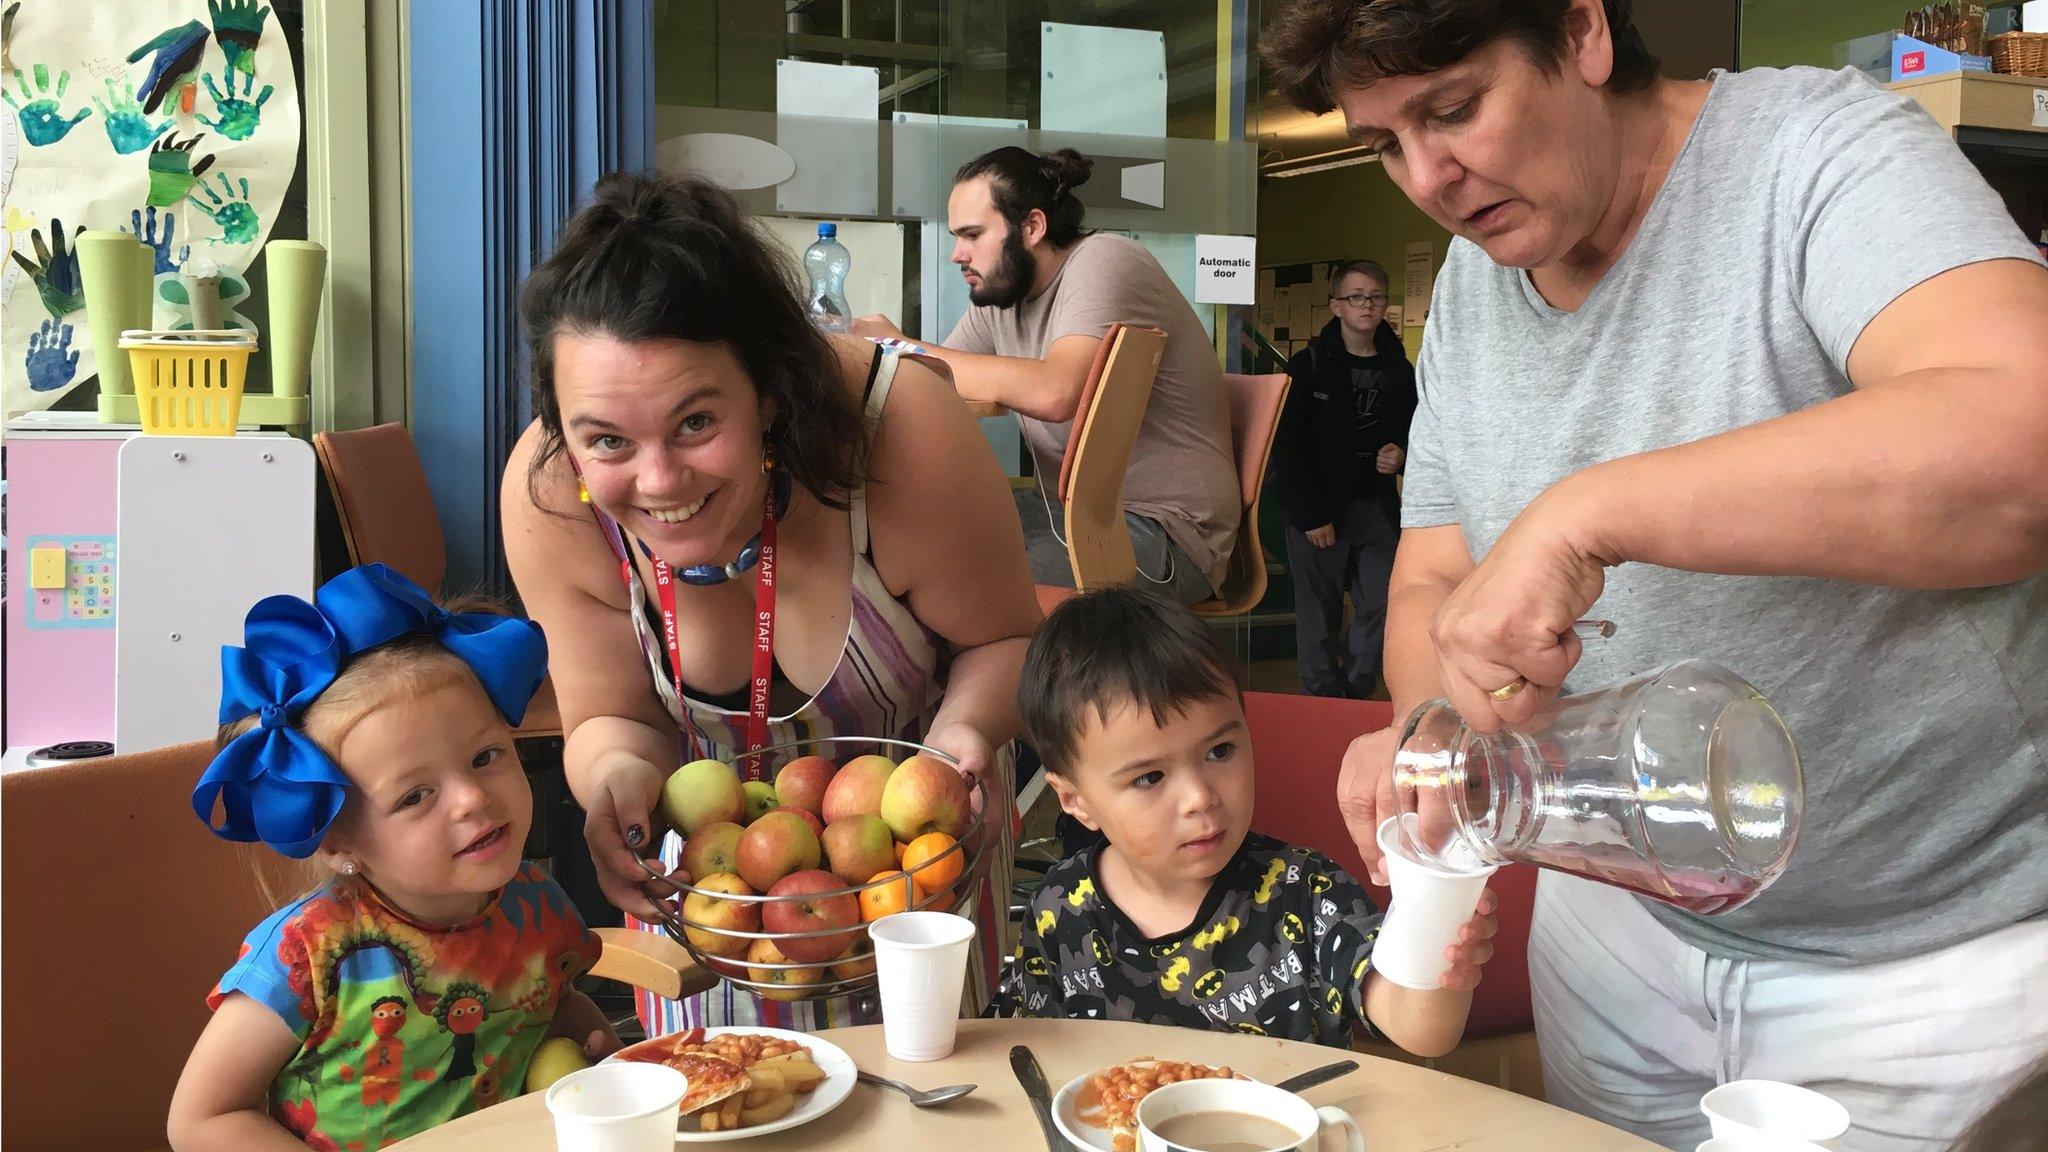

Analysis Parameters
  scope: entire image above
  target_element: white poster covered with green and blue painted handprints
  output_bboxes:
[0,0,301,416]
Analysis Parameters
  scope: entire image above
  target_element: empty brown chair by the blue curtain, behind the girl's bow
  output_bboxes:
[313,424,561,740]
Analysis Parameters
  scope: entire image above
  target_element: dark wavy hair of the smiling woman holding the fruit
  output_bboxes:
[518,172,868,508]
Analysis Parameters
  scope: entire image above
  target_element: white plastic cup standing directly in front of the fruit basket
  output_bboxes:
[868,912,975,1060]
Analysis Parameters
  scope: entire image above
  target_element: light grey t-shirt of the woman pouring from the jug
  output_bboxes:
[1401,68,2048,963]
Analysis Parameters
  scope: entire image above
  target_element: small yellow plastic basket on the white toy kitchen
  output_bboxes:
[121,328,256,437]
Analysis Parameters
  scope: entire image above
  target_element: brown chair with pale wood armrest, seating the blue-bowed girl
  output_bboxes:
[0,740,715,1152]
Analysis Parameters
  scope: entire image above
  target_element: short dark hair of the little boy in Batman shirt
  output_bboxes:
[1018,586,1237,779]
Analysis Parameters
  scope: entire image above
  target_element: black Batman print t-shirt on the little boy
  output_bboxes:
[1006,832,1380,1047]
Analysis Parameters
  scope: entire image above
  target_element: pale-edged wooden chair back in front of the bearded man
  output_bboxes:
[1038,324,1165,609]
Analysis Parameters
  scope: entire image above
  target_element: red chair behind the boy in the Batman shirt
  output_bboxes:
[1245,693,1542,1099]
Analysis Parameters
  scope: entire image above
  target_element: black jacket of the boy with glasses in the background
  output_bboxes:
[1274,318,1415,531]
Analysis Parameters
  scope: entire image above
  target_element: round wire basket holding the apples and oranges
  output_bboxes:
[643,736,997,1000]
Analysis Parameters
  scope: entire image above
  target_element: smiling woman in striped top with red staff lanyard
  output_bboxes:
[502,176,1038,1035]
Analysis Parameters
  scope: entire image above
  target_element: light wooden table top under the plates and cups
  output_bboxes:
[393,1021,1657,1152]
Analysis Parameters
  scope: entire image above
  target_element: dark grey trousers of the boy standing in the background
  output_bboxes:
[1286,498,1401,699]
